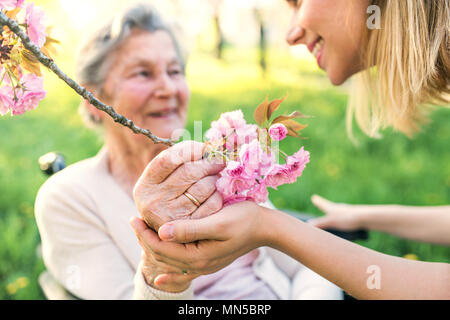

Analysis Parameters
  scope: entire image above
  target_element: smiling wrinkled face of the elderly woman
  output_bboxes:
[101,30,190,141]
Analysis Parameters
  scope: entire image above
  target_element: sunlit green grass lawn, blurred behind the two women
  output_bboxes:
[0,50,450,299]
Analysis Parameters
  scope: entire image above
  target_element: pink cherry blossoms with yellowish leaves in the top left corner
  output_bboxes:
[0,0,51,115]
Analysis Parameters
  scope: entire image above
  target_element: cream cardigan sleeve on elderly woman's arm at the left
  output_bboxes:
[35,177,192,300]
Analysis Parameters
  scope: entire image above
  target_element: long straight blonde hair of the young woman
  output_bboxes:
[347,0,450,137]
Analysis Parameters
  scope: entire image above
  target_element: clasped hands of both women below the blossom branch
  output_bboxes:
[131,141,268,292]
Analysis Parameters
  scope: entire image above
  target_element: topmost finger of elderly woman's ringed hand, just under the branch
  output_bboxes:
[138,141,204,185]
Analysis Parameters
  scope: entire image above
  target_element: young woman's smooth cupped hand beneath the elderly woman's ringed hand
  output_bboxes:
[130,201,270,282]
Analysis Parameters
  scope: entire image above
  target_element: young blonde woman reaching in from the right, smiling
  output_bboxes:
[131,0,450,299]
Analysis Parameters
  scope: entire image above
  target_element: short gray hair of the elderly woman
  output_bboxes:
[75,4,185,128]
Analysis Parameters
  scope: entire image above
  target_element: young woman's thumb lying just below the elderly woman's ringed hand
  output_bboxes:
[158,217,220,243]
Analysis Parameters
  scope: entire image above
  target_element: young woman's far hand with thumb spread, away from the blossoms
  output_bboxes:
[308,195,371,231]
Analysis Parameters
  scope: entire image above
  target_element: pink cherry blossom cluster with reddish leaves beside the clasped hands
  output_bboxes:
[206,99,309,205]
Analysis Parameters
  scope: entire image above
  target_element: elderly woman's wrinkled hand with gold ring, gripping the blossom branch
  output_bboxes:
[133,141,224,230]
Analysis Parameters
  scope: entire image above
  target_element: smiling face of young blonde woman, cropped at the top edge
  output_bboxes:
[286,0,369,85]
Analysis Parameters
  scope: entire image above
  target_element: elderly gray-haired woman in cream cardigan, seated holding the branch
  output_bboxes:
[35,5,342,299]
